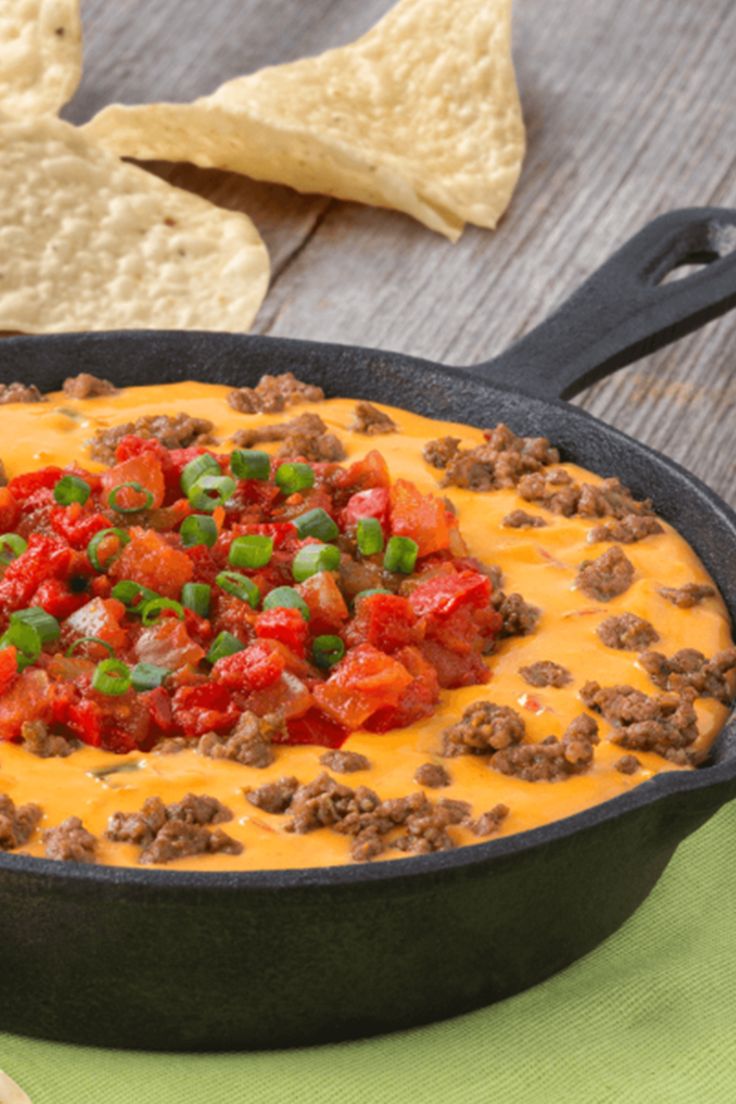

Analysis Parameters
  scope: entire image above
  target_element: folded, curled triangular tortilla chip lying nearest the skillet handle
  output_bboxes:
[83,0,524,241]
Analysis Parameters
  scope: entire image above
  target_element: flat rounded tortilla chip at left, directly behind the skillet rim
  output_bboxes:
[0,116,268,333]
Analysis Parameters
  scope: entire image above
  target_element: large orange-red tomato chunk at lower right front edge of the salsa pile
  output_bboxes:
[312,644,412,730]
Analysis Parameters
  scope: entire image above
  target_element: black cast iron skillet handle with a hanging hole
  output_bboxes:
[471,208,736,399]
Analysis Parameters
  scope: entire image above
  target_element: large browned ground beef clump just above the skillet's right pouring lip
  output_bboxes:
[580,682,697,764]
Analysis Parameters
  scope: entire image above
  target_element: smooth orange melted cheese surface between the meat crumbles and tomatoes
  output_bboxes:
[0,382,730,870]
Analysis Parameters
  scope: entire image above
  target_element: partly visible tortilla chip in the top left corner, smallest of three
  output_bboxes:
[0,0,82,118]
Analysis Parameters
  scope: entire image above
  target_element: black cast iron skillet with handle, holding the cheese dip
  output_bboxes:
[0,209,736,1050]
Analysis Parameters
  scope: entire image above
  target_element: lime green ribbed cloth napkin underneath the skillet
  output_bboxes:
[0,804,736,1104]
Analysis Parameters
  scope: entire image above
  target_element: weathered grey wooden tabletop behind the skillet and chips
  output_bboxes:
[64,0,736,505]
